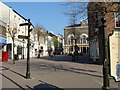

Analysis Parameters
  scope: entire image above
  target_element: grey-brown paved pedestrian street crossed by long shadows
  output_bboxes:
[0,56,118,90]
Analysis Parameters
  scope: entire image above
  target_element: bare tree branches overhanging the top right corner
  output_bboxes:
[63,0,120,20]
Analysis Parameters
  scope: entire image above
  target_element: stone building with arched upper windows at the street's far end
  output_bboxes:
[63,20,89,55]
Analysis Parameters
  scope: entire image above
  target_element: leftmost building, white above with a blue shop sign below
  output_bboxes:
[0,2,9,60]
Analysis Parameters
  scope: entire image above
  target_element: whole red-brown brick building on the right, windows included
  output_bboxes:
[88,2,120,64]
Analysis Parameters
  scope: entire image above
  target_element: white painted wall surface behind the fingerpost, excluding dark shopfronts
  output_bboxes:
[0,2,34,58]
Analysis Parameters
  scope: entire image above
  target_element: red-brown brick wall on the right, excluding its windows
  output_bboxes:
[88,3,120,64]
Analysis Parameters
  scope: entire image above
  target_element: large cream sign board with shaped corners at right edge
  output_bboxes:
[109,30,120,81]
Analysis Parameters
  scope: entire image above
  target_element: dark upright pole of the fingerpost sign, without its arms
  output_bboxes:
[26,19,30,79]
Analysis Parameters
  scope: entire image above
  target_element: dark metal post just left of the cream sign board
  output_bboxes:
[101,18,110,90]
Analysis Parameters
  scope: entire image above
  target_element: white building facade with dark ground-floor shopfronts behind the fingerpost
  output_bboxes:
[0,2,34,59]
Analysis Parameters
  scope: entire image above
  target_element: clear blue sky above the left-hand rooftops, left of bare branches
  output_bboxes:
[5,2,84,35]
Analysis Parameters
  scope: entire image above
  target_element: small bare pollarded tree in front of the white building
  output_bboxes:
[7,26,20,64]
